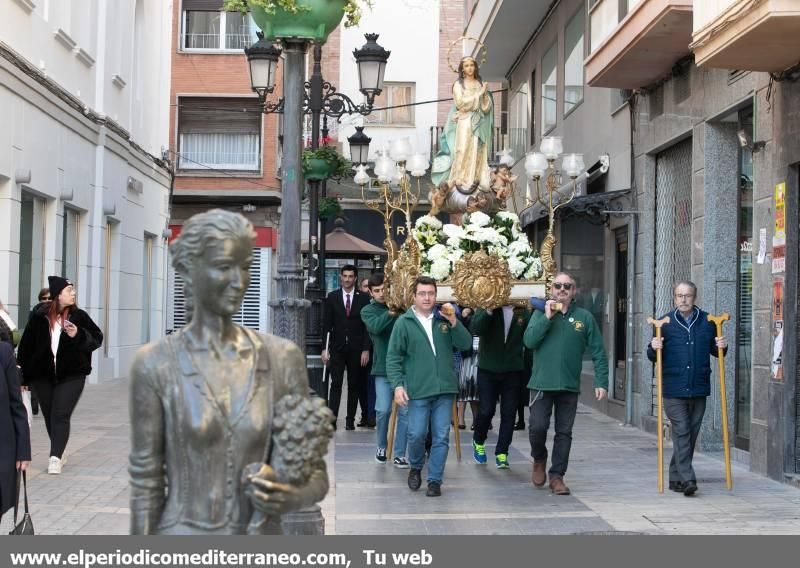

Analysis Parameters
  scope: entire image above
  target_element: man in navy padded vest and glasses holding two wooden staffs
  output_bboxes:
[647,281,728,497]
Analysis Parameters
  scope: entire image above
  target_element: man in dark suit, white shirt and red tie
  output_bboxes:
[322,264,370,430]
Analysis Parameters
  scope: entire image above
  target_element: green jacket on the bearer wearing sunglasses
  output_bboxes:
[523,304,608,392]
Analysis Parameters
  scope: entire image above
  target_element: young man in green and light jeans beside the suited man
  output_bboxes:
[361,272,408,469]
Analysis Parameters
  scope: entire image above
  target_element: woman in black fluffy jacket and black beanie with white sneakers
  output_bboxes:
[17,276,103,474]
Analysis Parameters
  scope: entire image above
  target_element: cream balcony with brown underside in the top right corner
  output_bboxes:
[691,0,800,72]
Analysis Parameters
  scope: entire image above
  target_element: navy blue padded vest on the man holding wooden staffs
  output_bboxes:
[647,306,718,398]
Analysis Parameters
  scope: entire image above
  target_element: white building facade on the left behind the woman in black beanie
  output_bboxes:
[0,0,172,382]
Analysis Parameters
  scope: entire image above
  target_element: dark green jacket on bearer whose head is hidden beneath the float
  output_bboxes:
[469,308,531,373]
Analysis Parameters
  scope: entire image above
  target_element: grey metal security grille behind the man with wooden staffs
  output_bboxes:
[652,138,692,414]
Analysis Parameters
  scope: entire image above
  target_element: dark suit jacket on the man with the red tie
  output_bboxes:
[322,288,372,351]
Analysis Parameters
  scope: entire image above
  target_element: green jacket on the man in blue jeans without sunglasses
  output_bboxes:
[386,309,472,399]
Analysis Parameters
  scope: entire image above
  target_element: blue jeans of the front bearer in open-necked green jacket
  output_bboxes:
[408,394,456,483]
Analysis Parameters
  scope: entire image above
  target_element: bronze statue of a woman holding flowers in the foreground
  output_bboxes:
[129,209,332,534]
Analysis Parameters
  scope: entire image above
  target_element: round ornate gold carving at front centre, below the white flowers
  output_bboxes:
[453,251,511,310]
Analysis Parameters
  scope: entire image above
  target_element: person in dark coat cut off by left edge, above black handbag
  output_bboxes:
[0,343,31,518]
